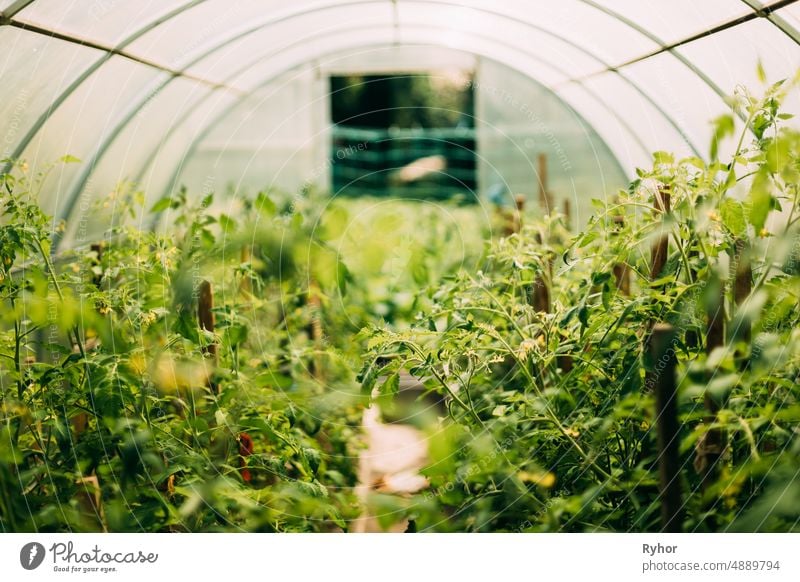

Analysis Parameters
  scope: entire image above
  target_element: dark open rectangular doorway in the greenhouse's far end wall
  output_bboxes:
[330,71,477,202]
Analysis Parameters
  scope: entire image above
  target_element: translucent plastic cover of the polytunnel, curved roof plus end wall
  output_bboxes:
[2,0,800,244]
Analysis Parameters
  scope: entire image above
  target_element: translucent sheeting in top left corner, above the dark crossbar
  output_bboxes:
[14,0,192,46]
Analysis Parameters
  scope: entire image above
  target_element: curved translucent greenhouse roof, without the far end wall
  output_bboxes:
[0,0,800,237]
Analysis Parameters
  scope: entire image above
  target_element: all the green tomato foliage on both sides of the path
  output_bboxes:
[0,84,800,531]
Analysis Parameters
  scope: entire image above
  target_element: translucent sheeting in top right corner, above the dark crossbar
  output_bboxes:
[596,0,752,44]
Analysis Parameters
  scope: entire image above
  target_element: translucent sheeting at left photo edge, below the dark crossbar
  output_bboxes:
[0,26,102,158]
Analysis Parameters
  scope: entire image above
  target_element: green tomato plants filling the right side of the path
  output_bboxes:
[362,84,800,531]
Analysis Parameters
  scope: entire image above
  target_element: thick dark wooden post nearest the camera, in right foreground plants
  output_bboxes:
[648,323,683,532]
